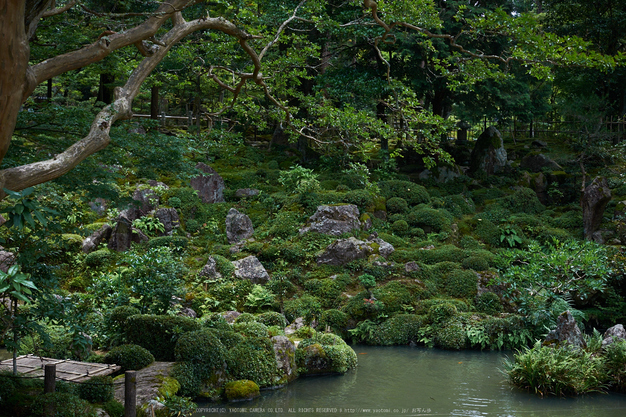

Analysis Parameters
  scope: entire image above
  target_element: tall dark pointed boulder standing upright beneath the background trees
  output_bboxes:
[469,126,508,175]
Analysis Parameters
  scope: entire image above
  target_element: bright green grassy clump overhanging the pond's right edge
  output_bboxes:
[505,342,606,396]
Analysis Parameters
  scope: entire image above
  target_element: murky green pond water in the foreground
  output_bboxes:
[194,346,626,417]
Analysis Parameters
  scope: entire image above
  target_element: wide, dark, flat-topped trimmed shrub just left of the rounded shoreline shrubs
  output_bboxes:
[126,314,200,362]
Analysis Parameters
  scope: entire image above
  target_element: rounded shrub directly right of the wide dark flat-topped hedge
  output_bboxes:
[174,329,228,368]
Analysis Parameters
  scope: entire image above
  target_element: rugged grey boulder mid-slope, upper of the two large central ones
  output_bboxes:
[300,204,361,236]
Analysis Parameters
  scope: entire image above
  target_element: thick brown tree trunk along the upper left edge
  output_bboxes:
[0,0,30,166]
